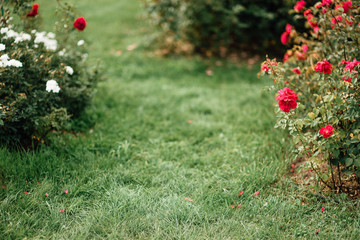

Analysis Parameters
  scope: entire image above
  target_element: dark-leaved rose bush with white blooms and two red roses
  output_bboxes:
[0,0,99,148]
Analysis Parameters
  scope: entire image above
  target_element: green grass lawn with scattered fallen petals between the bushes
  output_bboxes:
[0,0,360,239]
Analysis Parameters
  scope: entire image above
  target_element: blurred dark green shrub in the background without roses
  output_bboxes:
[146,0,294,54]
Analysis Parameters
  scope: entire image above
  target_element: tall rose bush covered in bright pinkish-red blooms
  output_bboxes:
[261,0,360,194]
